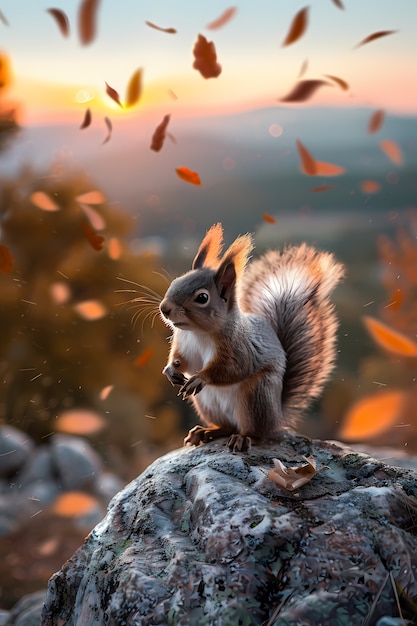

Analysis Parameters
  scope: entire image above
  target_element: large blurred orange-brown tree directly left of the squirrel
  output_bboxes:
[0,164,179,470]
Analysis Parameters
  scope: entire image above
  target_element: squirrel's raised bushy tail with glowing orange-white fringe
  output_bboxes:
[240,244,343,422]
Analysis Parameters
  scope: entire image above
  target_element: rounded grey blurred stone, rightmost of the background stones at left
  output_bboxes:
[51,435,103,491]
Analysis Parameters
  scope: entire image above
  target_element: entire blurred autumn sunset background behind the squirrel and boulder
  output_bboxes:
[0,0,417,608]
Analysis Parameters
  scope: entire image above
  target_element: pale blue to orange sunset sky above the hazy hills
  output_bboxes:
[0,0,417,124]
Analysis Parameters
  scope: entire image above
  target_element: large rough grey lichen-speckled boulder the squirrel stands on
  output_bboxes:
[41,433,417,626]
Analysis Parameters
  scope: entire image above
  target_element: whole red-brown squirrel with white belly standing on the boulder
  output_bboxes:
[159,223,344,452]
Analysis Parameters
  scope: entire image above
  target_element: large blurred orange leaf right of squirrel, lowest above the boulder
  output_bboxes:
[338,390,406,441]
